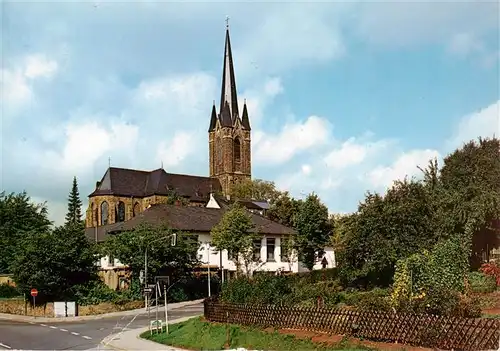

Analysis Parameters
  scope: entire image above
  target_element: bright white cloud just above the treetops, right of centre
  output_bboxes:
[367,149,440,189]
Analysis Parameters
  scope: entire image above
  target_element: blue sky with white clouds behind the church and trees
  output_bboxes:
[0,0,500,224]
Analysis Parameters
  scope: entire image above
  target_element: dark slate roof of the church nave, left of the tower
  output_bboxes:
[89,167,222,202]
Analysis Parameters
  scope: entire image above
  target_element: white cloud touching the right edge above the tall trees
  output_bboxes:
[447,100,500,149]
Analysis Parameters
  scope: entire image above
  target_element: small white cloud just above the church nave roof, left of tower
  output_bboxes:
[156,131,196,167]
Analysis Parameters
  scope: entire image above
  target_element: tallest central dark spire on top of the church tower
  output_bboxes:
[220,18,239,120]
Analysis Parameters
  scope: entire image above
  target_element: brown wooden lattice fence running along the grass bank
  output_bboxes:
[204,297,500,351]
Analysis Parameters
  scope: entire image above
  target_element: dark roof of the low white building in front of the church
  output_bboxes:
[85,204,294,241]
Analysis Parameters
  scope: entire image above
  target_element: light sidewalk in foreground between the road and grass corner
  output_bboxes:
[101,316,196,351]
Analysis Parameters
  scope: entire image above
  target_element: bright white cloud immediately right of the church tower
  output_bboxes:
[253,116,331,165]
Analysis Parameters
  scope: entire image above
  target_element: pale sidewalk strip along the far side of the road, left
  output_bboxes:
[0,299,205,324]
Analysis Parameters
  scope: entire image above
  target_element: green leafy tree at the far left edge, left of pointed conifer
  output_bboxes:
[0,192,51,273]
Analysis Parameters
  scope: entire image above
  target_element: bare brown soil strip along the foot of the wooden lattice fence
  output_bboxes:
[279,329,433,351]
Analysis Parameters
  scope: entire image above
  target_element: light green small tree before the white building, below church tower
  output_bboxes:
[211,204,260,274]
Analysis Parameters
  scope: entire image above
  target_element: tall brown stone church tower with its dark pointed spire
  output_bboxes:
[208,21,252,195]
